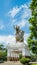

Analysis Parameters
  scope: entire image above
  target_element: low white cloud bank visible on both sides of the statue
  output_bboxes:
[0,33,29,45]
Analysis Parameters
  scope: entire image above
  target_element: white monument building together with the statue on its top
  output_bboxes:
[7,26,30,61]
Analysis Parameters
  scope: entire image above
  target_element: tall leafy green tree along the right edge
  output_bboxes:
[28,0,37,55]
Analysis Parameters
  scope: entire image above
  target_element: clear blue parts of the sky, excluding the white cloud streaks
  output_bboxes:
[0,0,31,35]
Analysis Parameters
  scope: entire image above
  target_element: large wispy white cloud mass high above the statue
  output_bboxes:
[8,4,31,28]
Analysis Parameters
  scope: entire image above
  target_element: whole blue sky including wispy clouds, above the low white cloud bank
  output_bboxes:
[0,0,31,44]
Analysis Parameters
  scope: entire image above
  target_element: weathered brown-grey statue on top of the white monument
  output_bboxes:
[14,26,24,42]
